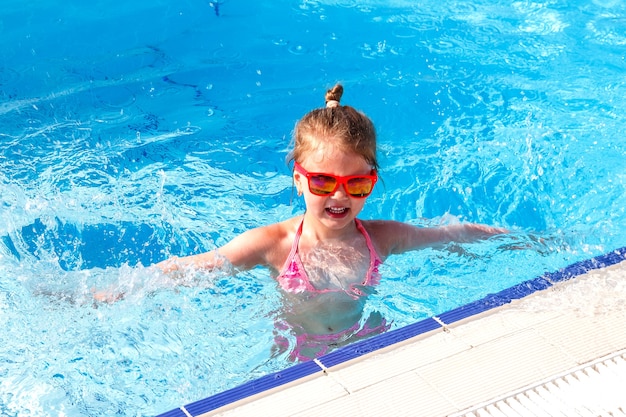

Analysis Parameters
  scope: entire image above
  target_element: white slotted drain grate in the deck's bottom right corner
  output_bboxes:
[450,350,626,417]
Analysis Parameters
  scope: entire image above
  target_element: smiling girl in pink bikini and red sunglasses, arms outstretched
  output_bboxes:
[152,85,506,360]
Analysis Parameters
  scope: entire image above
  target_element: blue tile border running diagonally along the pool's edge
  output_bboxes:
[157,247,626,417]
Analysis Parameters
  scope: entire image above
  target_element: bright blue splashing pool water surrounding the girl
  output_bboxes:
[0,0,626,416]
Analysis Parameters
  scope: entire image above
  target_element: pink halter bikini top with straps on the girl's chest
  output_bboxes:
[277,218,382,295]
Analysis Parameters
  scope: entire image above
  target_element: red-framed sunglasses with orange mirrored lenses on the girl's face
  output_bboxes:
[293,162,378,198]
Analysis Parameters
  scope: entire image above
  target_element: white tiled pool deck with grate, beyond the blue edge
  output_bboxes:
[160,249,626,417]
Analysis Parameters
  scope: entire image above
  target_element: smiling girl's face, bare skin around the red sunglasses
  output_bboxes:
[293,145,372,234]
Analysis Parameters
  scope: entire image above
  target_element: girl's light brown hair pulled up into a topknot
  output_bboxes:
[287,84,378,170]
